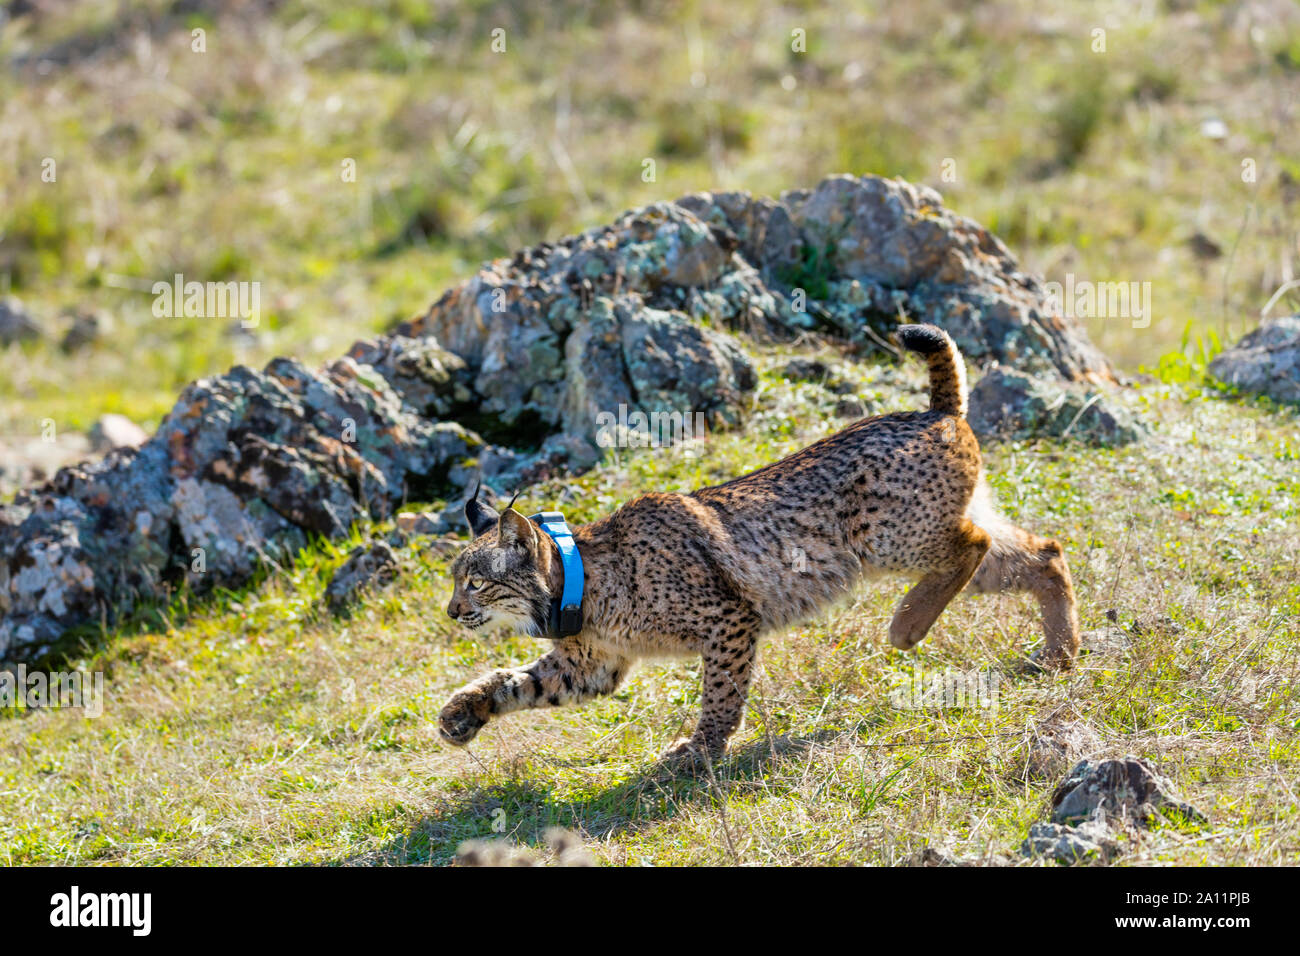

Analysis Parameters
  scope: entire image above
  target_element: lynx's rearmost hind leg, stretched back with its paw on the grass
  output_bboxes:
[970,519,1079,667]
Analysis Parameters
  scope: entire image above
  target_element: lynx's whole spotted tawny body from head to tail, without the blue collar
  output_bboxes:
[439,325,1079,758]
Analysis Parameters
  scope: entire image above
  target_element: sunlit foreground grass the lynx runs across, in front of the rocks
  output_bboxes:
[0,349,1300,865]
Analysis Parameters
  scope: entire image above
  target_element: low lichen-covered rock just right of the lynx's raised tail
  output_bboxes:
[966,365,1145,445]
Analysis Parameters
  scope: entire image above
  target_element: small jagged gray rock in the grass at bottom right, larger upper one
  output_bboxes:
[1052,757,1205,826]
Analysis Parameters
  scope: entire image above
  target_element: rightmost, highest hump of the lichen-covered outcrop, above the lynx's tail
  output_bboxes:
[676,176,1114,381]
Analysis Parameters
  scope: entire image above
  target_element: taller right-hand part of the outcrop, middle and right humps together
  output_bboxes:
[402,176,1113,421]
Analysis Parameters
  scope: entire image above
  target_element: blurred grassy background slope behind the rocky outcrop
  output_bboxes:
[0,0,1300,433]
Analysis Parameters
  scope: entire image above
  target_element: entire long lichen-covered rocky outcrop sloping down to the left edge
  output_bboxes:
[0,176,1112,659]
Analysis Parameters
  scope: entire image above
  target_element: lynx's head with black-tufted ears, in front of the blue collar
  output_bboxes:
[447,488,551,635]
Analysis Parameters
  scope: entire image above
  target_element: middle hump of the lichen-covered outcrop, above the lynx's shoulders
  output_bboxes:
[399,203,759,440]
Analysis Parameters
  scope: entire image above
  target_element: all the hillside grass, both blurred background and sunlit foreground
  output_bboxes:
[0,0,1300,864]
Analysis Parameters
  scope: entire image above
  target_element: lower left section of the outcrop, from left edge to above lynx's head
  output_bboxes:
[0,358,484,659]
